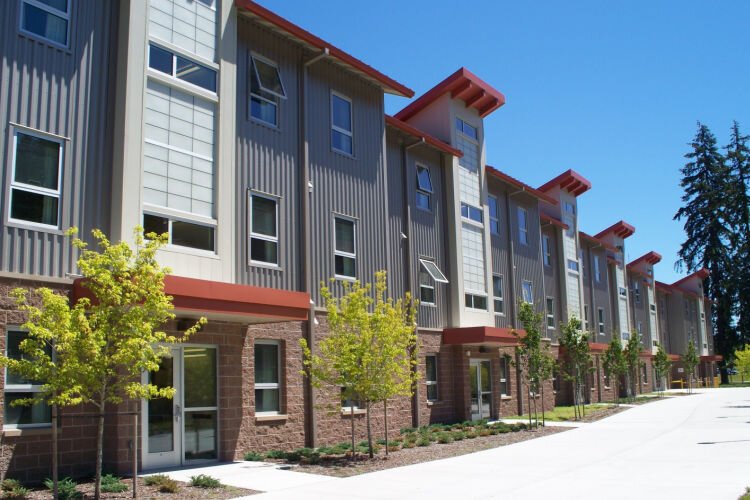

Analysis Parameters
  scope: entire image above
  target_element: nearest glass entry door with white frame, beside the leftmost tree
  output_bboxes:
[142,346,218,469]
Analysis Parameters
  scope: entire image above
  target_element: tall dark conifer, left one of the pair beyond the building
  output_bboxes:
[674,122,738,378]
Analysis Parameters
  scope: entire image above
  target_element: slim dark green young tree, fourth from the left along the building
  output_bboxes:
[559,316,591,420]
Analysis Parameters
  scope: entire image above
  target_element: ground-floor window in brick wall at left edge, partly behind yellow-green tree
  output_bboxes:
[3,328,52,428]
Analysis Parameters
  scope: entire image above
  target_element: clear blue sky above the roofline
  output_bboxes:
[260,0,750,282]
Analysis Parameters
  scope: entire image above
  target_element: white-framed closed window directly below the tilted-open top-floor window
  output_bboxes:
[250,194,279,265]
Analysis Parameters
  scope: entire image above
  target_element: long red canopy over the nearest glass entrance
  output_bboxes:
[73,275,310,322]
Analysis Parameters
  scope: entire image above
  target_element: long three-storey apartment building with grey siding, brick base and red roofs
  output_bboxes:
[0,0,715,480]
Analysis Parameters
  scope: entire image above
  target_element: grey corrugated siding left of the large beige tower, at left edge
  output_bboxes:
[0,0,119,277]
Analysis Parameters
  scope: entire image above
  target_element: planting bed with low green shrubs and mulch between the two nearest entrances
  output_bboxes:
[248,421,566,477]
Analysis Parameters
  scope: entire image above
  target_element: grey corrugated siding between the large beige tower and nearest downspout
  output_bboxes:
[236,17,302,290]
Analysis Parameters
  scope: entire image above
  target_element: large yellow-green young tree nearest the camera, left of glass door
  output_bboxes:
[0,228,206,498]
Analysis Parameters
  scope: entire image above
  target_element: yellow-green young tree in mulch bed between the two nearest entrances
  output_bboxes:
[300,271,418,457]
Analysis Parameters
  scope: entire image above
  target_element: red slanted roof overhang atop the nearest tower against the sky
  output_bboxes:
[396,68,505,121]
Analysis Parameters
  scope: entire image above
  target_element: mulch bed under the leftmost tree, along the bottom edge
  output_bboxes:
[19,478,261,500]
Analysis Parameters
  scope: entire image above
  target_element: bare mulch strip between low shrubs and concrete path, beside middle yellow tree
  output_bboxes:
[292,427,569,477]
